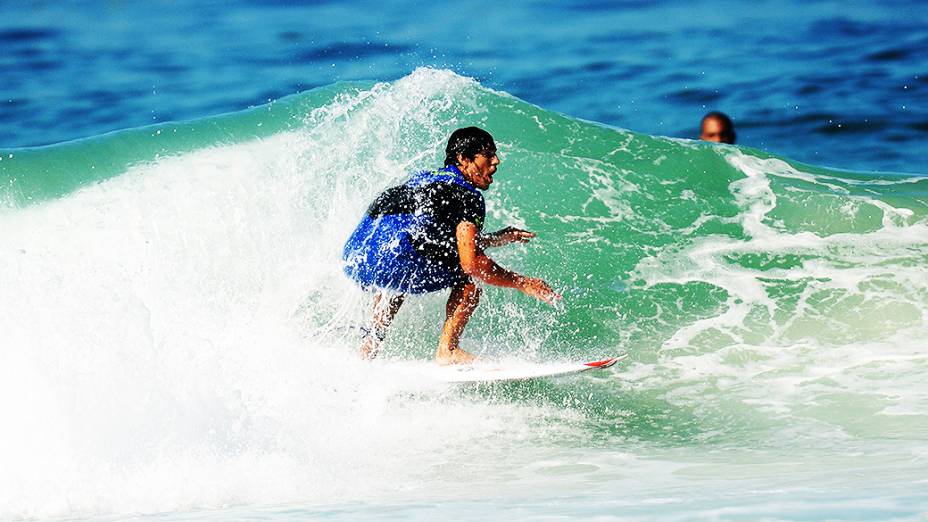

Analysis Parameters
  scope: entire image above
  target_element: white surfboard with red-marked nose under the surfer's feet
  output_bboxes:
[434,354,628,383]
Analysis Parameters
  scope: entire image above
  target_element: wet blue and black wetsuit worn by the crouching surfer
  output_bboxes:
[343,165,486,293]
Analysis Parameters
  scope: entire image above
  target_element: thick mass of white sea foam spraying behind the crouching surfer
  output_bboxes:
[0,71,588,518]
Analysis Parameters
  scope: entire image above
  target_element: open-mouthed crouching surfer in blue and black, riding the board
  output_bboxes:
[343,127,561,364]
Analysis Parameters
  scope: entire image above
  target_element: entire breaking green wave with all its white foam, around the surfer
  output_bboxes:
[0,69,928,520]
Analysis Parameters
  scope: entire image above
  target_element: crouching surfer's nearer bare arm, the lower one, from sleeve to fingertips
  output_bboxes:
[456,221,561,304]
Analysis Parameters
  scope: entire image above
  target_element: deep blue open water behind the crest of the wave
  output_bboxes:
[0,0,928,173]
